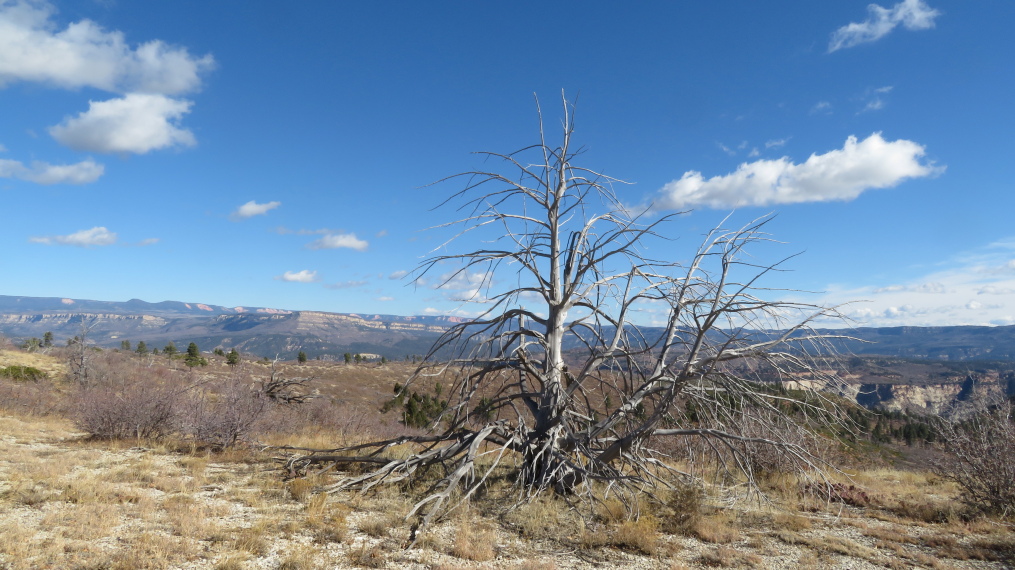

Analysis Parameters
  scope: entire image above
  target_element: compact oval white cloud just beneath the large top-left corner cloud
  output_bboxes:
[49,93,197,154]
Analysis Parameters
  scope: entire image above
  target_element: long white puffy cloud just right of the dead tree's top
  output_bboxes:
[654,133,944,210]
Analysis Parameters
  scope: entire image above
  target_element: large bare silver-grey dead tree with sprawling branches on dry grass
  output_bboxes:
[287,95,856,539]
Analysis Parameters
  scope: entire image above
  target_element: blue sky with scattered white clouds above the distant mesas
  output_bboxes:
[0,0,1015,326]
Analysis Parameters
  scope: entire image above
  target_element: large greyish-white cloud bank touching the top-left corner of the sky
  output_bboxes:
[0,0,215,94]
